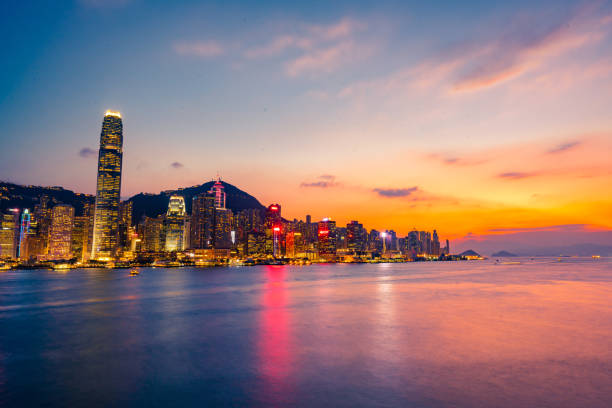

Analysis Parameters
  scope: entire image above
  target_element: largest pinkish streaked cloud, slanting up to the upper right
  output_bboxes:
[337,4,612,99]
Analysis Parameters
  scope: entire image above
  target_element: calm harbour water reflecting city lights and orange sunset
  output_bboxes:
[0,259,612,407]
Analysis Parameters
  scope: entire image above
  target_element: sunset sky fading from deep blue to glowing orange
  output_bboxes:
[0,0,612,253]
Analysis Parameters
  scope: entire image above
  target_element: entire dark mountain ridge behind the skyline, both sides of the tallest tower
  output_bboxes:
[0,181,265,223]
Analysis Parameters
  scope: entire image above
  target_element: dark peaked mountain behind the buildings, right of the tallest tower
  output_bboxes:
[129,181,266,222]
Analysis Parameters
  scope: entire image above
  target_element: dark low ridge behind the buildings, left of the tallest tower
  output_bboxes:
[0,182,96,215]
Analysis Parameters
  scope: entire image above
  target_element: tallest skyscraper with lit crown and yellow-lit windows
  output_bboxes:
[91,111,123,260]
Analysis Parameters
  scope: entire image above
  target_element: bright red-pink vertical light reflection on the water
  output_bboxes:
[258,266,292,402]
